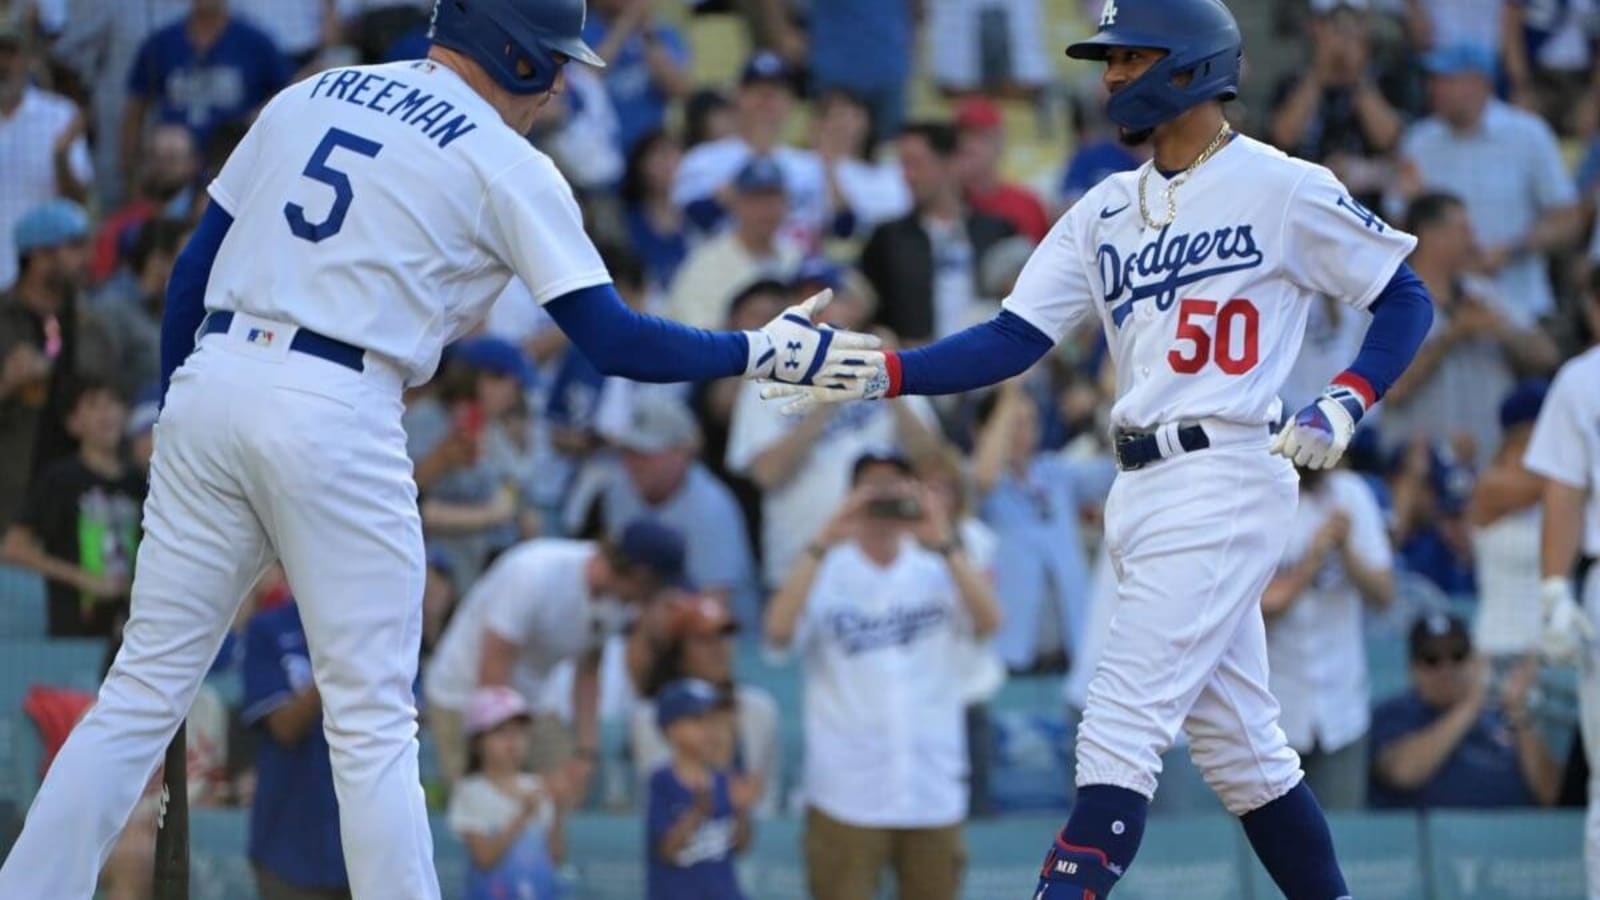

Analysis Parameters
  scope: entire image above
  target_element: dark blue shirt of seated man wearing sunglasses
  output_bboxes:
[1368,692,1538,809]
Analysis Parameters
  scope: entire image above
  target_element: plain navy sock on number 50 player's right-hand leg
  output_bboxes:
[1240,781,1350,900]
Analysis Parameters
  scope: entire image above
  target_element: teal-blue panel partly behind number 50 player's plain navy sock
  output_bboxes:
[1246,812,1427,900]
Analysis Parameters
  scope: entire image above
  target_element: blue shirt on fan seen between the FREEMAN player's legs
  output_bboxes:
[243,604,349,889]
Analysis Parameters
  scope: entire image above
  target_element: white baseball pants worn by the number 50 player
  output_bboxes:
[1077,420,1301,815]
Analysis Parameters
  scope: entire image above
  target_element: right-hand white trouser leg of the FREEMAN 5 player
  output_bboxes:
[236,369,438,900]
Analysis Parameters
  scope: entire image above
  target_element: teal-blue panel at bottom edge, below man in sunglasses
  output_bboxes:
[1426,810,1584,900]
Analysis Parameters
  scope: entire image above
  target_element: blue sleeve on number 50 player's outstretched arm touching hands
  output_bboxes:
[888,311,1054,396]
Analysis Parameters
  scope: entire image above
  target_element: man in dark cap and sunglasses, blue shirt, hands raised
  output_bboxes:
[1368,613,1562,809]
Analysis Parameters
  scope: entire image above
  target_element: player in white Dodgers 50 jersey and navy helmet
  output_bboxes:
[763,0,1432,900]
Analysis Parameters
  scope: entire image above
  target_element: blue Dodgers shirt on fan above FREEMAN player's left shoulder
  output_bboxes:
[128,19,291,151]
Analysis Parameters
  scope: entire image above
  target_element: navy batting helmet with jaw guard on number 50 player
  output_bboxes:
[1067,0,1245,131]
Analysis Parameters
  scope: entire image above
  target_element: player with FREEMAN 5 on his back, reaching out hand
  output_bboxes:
[0,0,870,900]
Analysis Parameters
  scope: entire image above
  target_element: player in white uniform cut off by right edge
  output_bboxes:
[1523,267,1600,900]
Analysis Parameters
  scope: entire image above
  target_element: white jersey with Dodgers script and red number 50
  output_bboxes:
[1005,135,1416,429]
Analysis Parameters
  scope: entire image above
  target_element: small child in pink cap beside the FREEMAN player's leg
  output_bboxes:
[450,685,565,900]
